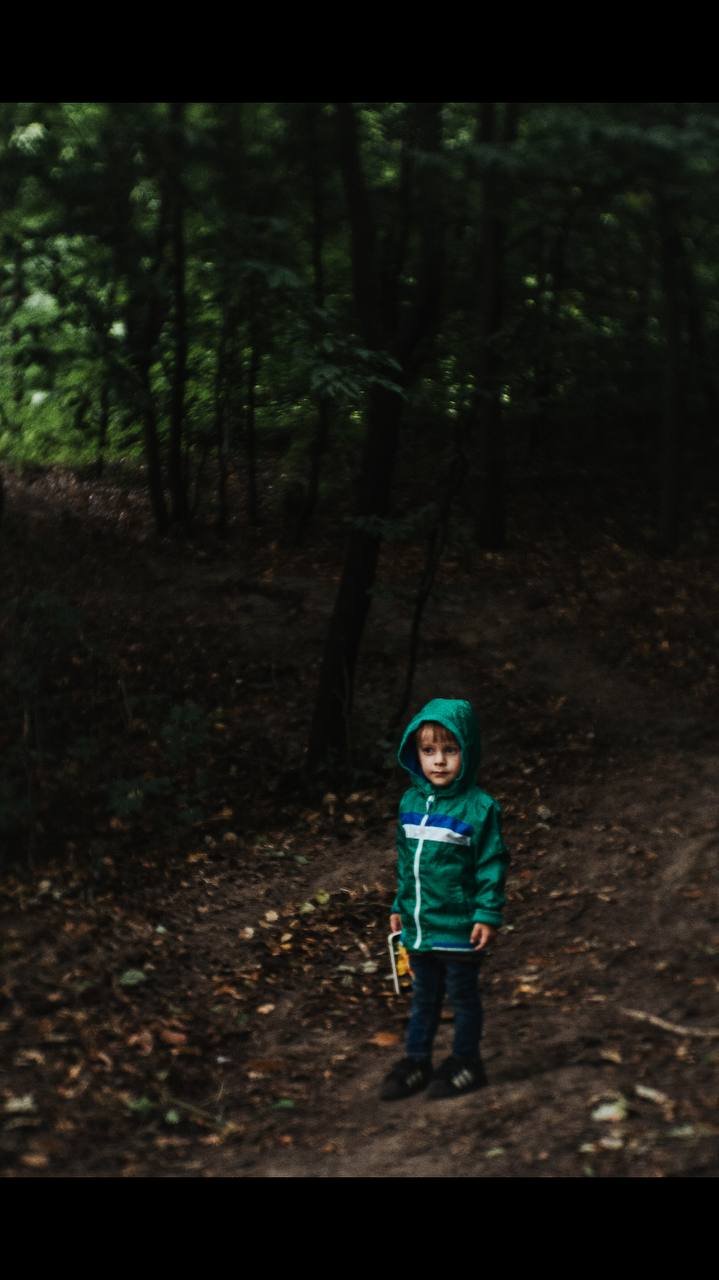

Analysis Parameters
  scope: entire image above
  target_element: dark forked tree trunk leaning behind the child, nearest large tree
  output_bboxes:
[307,102,444,771]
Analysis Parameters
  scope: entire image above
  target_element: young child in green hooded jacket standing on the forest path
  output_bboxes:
[381,698,507,1101]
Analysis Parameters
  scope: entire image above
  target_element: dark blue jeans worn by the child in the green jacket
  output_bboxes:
[407,951,482,1057]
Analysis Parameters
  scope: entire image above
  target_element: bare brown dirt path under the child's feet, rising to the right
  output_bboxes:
[177,737,719,1178]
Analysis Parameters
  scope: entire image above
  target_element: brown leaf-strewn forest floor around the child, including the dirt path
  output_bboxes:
[0,472,719,1178]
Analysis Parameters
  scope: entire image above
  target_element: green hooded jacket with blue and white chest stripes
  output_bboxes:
[391,698,508,952]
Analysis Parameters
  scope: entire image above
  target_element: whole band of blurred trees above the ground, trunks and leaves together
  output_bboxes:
[0,102,719,765]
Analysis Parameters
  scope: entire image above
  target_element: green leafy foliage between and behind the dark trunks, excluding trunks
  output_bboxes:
[0,102,719,535]
